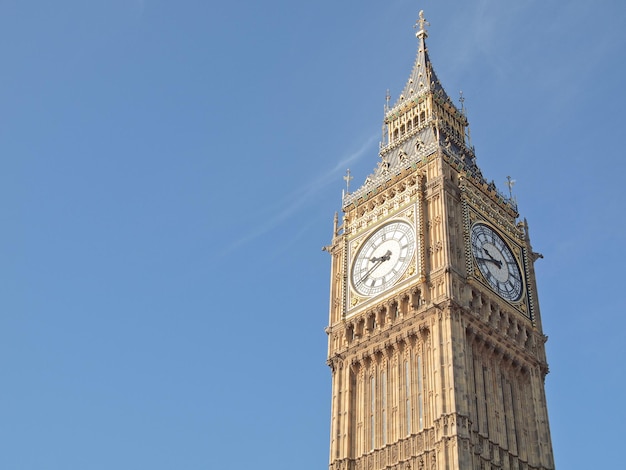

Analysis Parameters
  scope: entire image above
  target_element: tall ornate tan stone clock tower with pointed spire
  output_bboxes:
[326,12,554,470]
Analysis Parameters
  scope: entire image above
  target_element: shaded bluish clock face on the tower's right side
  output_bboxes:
[471,224,522,302]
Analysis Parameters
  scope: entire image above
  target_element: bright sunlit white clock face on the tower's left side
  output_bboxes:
[351,221,415,296]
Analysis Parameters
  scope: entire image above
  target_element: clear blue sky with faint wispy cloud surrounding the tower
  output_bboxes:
[0,0,626,470]
